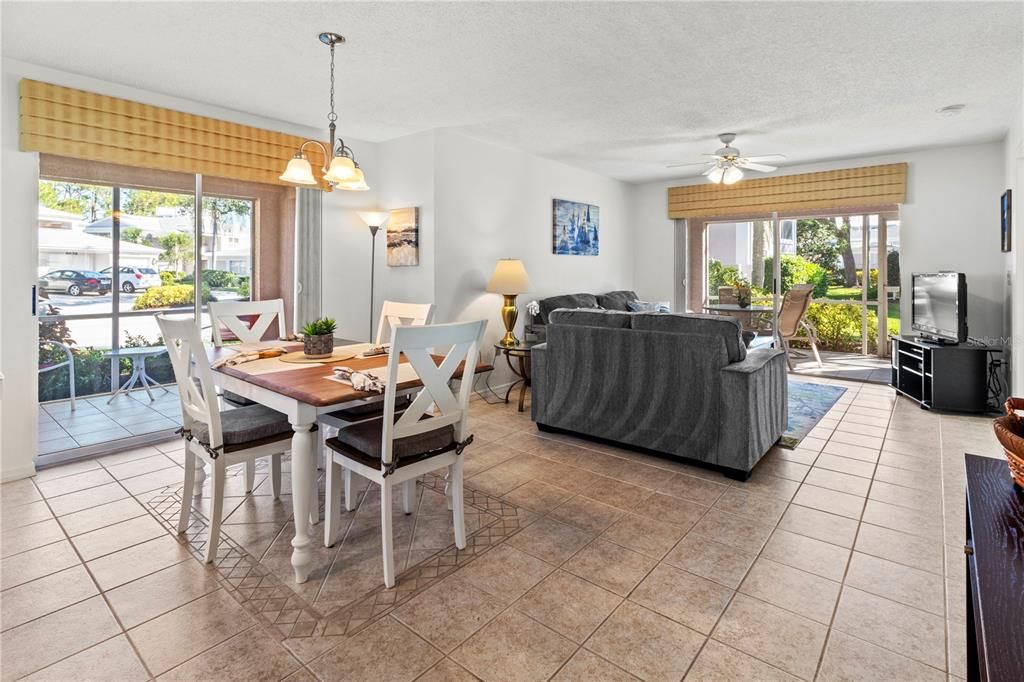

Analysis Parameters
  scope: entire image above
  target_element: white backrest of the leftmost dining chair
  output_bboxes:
[155,314,223,447]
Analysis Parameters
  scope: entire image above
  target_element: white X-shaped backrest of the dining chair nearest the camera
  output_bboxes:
[381,319,486,464]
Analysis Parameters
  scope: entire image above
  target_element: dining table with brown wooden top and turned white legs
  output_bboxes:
[208,340,494,583]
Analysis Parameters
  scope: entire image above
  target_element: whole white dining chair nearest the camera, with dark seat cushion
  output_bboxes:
[324,319,486,588]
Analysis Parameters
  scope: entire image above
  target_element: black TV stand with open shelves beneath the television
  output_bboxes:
[889,336,997,413]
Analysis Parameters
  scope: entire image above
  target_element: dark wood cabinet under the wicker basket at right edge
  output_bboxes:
[964,455,1024,682]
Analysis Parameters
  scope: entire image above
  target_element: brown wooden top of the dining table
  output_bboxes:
[208,341,494,408]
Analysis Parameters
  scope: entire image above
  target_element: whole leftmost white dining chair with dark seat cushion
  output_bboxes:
[156,314,293,563]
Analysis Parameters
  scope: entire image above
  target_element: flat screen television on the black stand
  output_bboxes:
[911,272,967,343]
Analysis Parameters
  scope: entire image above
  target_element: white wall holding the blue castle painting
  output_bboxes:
[434,131,635,376]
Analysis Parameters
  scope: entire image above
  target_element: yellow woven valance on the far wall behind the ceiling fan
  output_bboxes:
[669,163,906,219]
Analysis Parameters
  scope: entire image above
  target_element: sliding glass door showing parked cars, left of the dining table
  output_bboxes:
[37,179,255,464]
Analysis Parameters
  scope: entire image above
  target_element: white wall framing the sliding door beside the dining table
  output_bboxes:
[0,58,376,480]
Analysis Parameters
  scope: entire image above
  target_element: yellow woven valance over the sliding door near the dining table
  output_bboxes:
[18,79,330,190]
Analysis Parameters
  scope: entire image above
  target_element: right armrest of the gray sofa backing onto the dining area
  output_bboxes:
[719,348,788,471]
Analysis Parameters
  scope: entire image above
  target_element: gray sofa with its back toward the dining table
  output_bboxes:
[532,309,787,480]
